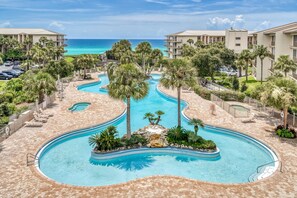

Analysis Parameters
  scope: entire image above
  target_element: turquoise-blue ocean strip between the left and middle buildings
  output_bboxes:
[65,39,167,56]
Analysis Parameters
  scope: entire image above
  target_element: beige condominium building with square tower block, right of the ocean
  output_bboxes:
[165,29,249,58]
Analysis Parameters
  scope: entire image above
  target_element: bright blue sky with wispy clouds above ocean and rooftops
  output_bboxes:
[0,0,297,38]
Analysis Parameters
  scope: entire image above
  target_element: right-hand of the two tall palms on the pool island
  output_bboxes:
[160,59,197,126]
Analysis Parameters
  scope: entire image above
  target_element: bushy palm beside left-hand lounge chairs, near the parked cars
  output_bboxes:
[24,71,56,104]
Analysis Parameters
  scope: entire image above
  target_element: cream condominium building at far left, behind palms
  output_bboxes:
[0,28,65,46]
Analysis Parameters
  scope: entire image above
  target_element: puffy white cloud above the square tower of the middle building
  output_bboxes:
[207,15,245,29]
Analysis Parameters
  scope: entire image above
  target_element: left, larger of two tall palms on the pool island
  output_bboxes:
[107,64,149,138]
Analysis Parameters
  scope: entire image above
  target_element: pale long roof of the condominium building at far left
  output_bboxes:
[0,28,63,35]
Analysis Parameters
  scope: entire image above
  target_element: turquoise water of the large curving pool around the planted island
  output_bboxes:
[39,75,274,186]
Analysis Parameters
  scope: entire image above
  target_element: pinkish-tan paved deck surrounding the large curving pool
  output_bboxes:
[0,73,297,197]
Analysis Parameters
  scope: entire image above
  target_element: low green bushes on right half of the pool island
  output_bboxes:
[167,127,216,150]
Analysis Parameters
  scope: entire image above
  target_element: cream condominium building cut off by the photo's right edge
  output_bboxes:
[253,22,297,80]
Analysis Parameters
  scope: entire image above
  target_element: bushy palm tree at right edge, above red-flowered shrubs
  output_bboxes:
[260,77,297,128]
